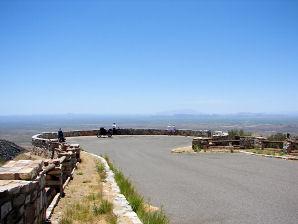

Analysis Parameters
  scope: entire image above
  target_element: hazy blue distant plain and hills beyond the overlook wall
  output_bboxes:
[0,114,298,146]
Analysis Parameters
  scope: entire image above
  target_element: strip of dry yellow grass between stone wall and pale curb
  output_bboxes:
[51,153,117,224]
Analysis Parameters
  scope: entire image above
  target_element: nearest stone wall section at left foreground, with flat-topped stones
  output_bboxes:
[0,139,80,224]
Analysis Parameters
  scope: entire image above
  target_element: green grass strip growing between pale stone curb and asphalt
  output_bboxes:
[104,156,169,224]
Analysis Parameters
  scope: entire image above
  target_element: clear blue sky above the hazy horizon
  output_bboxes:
[0,0,298,115]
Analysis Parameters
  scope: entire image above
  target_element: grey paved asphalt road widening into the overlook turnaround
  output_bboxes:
[69,136,298,224]
